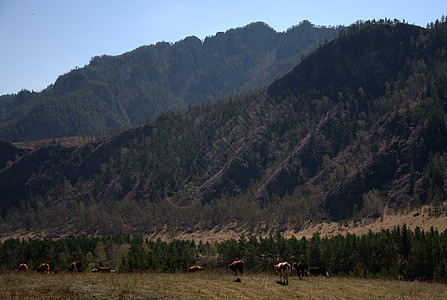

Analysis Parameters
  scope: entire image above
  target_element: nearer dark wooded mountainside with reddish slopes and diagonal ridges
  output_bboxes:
[0,20,447,236]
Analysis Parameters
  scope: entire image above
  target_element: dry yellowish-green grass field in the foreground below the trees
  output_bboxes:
[0,271,447,300]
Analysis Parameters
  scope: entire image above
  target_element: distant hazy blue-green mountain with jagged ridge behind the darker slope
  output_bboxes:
[0,21,340,142]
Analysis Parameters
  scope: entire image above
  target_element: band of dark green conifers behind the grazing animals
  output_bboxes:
[0,225,447,282]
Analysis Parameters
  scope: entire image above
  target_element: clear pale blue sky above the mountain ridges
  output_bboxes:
[0,0,447,95]
